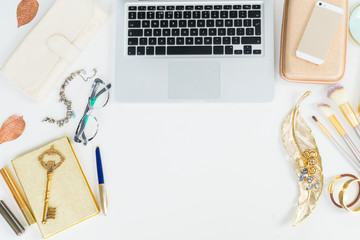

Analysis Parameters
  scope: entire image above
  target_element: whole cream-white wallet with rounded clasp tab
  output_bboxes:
[1,0,107,101]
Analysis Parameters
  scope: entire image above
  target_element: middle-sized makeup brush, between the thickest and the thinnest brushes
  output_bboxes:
[318,103,360,163]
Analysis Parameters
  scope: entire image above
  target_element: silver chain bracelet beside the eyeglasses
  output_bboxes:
[42,68,97,127]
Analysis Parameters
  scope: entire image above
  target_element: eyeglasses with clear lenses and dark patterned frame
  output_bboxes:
[74,78,111,145]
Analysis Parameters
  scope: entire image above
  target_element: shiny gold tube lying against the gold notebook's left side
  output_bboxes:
[0,168,36,225]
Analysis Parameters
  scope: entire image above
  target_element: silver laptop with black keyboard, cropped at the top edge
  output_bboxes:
[115,0,274,102]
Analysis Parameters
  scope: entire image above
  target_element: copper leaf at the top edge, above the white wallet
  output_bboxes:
[16,0,39,28]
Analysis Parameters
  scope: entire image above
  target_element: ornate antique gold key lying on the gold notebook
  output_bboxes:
[38,145,65,224]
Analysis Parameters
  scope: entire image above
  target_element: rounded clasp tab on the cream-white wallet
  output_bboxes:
[48,34,80,64]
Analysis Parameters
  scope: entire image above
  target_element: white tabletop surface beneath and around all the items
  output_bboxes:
[0,0,360,240]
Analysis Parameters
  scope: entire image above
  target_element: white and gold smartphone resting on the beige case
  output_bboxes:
[296,1,344,65]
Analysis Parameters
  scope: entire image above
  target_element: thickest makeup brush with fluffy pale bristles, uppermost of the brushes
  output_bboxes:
[328,85,360,138]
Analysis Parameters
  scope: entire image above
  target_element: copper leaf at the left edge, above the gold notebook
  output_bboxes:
[0,115,25,144]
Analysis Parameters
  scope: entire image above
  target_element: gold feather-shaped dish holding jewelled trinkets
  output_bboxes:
[281,91,324,226]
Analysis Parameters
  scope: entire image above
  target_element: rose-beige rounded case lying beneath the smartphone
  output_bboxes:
[280,0,348,83]
